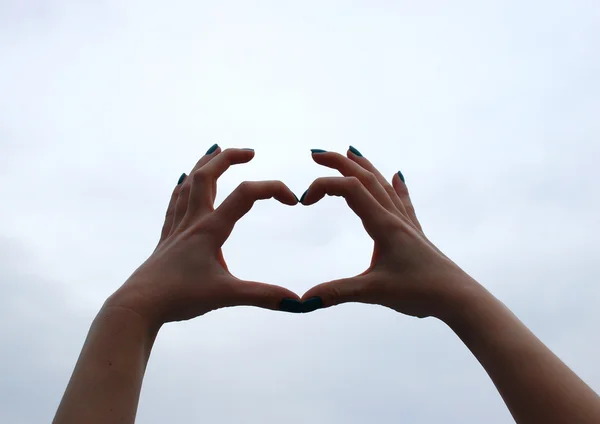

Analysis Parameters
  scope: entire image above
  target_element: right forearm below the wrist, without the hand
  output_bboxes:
[443,283,600,424]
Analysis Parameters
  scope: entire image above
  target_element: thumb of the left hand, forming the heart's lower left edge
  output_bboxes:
[233,280,302,312]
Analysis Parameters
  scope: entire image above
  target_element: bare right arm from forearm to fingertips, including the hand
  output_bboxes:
[302,148,600,424]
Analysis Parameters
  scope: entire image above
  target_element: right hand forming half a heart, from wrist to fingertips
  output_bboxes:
[301,148,477,317]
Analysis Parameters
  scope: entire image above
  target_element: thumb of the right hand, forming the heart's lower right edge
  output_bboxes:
[302,274,373,312]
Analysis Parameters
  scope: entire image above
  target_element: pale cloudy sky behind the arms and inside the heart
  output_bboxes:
[0,0,600,424]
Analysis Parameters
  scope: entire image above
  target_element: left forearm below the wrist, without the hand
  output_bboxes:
[53,306,158,424]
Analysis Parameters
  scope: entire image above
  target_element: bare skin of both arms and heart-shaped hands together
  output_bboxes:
[54,149,600,424]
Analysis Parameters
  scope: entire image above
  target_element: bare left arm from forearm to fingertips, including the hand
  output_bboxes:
[54,148,300,424]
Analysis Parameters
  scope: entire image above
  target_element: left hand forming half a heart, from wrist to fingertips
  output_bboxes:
[105,147,299,325]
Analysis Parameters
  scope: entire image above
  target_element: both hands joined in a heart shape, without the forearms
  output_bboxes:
[106,146,470,326]
